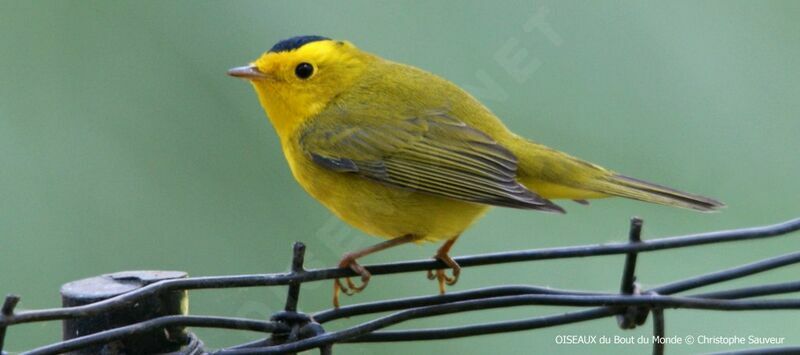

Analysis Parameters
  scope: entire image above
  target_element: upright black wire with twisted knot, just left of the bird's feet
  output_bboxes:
[266,242,333,355]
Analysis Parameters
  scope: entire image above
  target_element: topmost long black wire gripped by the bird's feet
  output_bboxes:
[0,218,800,327]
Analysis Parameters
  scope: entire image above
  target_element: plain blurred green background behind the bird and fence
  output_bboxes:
[0,1,800,354]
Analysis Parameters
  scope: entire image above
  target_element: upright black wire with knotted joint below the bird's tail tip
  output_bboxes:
[617,217,664,355]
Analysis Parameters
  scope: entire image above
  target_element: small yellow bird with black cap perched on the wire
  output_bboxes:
[228,36,724,307]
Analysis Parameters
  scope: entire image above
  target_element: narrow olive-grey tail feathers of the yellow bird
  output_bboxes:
[597,174,725,212]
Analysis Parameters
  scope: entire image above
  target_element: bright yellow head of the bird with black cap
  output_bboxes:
[228,36,370,137]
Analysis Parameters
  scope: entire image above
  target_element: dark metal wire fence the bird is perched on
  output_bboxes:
[0,218,800,355]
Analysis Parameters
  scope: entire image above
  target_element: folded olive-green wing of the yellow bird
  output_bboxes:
[299,111,564,213]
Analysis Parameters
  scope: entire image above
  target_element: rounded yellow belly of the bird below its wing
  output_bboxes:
[284,141,488,241]
